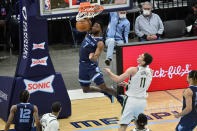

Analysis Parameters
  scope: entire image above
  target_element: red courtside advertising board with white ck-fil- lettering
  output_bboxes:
[117,37,197,91]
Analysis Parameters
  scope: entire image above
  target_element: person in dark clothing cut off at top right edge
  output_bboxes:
[185,2,197,36]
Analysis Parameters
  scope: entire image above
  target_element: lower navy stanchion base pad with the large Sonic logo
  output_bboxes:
[11,73,71,118]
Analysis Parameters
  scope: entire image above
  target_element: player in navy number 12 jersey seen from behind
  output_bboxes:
[5,90,41,131]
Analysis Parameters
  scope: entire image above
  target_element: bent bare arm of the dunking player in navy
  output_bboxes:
[89,41,104,61]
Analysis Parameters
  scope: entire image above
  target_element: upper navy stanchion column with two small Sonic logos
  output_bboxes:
[16,0,55,78]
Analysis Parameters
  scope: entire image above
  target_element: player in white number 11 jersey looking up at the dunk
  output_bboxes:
[105,53,153,131]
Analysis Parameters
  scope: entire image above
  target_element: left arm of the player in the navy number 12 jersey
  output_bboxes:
[4,105,17,131]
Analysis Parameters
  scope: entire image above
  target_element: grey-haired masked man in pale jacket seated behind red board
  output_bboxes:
[135,2,164,41]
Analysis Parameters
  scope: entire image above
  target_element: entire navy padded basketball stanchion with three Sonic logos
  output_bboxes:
[0,0,71,121]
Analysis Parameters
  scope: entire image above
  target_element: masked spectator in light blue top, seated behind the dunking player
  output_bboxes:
[105,11,130,66]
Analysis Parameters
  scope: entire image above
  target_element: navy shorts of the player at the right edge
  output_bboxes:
[176,115,197,131]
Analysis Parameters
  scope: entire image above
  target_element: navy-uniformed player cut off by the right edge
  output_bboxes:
[174,70,197,131]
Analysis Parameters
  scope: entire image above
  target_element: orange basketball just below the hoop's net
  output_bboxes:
[76,19,91,32]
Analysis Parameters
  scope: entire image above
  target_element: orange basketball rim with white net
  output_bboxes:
[76,2,104,21]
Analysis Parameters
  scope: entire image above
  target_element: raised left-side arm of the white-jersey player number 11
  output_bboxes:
[104,67,136,83]
